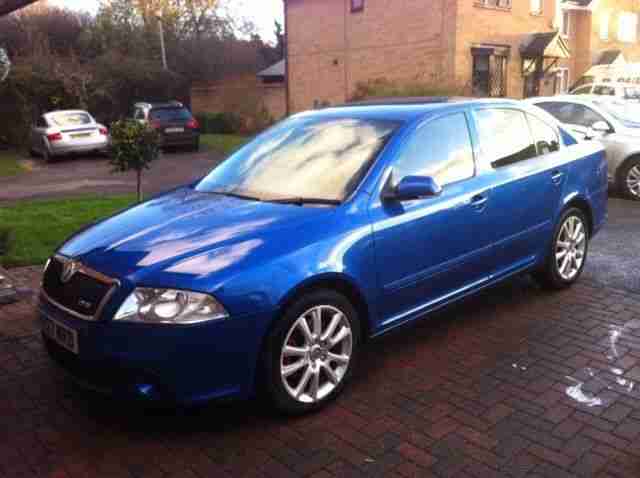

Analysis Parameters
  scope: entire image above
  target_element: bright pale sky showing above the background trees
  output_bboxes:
[49,0,284,41]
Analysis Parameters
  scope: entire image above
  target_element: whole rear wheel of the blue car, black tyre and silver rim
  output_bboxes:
[534,207,589,289]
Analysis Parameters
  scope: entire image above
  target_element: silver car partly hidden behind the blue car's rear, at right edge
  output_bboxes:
[529,96,640,201]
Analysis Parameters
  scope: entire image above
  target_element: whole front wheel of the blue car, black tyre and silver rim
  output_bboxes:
[263,290,361,415]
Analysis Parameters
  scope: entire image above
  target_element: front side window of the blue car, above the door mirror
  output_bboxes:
[393,113,475,186]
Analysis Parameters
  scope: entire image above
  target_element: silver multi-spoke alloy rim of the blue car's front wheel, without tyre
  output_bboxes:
[280,305,353,404]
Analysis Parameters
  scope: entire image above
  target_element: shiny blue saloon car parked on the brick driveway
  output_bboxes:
[39,100,607,413]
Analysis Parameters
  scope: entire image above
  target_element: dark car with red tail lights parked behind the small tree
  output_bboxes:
[133,101,200,151]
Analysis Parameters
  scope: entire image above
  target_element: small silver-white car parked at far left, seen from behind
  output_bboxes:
[29,110,109,162]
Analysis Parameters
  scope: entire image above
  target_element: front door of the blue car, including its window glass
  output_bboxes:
[370,111,493,330]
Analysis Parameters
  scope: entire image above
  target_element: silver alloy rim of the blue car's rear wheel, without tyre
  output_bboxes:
[555,216,587,281]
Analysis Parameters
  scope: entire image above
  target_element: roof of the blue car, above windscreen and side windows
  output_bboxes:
[299,97,523,122]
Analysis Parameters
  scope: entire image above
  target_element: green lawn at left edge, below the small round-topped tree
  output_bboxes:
[0,196,135,267]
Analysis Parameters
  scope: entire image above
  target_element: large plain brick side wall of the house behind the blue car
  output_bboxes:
[287,0,456,111]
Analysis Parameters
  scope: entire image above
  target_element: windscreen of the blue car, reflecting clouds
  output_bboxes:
[196,116,400,201]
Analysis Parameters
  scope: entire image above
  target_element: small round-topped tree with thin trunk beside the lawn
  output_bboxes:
[110,119,160,202]
